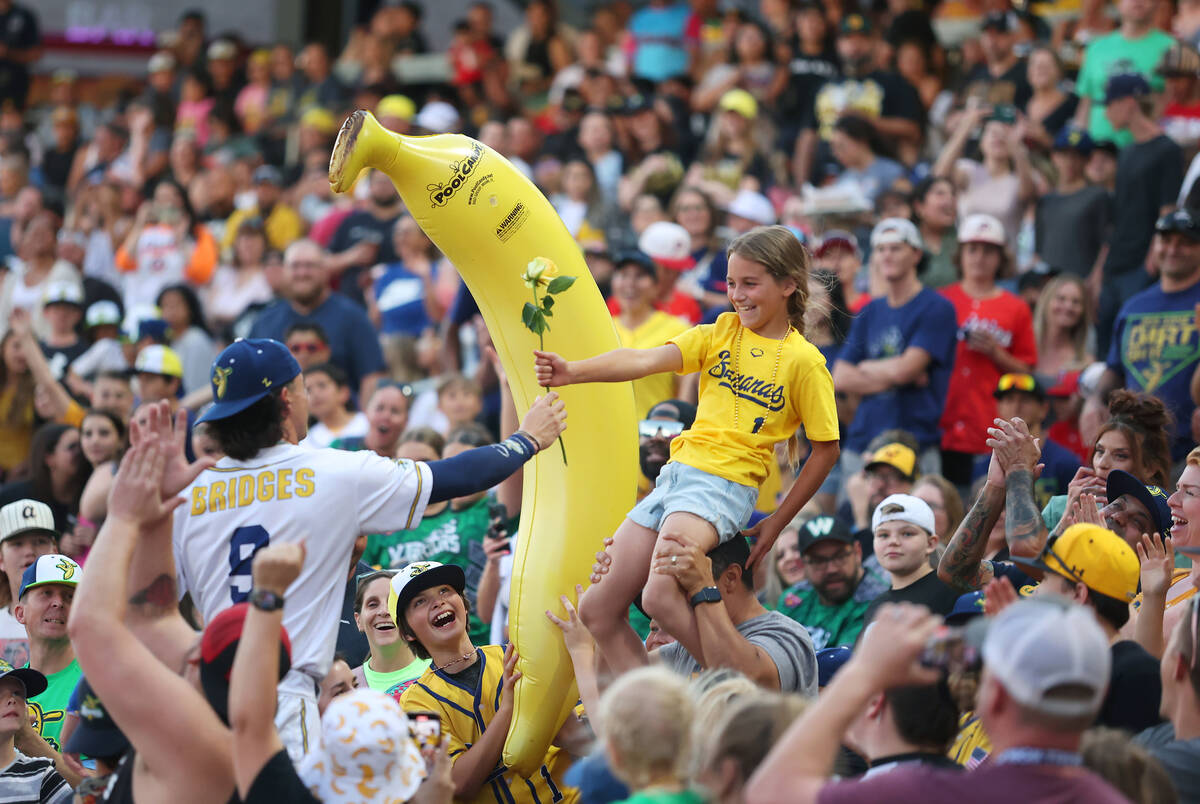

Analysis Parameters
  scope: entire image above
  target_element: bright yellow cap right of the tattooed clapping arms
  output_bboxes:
[1013,522,1140,601]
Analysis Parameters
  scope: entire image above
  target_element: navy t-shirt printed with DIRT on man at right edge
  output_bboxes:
[1108,282,1200,461]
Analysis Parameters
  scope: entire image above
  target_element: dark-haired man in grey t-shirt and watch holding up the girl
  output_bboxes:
[652,535,817,697]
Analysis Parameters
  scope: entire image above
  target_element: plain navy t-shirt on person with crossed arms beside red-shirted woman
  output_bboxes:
[838,288,958,452]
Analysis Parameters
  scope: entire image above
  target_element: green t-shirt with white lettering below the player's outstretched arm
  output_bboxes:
[362,497,496,644]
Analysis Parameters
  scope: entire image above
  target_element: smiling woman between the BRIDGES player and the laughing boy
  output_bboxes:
[354,570,430,701]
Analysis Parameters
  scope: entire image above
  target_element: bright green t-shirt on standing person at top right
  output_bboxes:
[1076,30,1175,148]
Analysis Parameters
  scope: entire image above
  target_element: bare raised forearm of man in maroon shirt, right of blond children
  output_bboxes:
[745,659,878,804]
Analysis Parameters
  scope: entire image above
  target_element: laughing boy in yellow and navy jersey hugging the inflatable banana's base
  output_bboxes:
[388,562,578,804]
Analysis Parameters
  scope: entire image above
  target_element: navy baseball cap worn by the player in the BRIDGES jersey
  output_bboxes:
[197,338,300,422]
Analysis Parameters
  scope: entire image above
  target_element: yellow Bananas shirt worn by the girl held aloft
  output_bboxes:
[668,313,839,488]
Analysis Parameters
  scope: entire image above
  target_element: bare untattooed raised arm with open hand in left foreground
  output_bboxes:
[68,440,234,798]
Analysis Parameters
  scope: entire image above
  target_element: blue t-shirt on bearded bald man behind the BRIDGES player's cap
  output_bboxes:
[250,293,385,390]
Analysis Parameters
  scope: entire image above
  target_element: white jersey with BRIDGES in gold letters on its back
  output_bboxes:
[174,444,433,697]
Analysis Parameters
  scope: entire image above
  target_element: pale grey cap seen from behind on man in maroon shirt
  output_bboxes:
[979,596,1112,718]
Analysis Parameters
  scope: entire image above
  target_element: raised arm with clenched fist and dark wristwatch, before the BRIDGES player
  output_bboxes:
[229,542,305,798]
